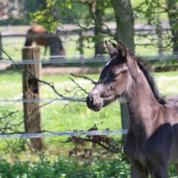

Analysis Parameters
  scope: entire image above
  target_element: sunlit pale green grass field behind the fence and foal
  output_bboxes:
[0,70,178,158]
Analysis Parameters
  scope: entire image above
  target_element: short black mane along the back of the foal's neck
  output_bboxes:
[137,60,166,105]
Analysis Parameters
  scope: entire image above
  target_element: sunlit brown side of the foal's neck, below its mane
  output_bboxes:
[126,69,160,137]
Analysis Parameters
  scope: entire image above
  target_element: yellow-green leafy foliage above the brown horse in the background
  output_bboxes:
[33,0,89,32]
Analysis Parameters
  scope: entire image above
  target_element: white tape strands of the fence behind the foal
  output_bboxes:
[0,28,178,142]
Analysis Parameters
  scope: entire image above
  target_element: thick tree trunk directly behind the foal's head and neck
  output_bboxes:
[111,0,135,129]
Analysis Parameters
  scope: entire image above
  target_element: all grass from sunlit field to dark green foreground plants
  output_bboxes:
[0,70,178,178]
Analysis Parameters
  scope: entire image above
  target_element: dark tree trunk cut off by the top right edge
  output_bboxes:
[166,0,178,53]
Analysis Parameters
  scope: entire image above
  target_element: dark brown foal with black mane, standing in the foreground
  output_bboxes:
[86,42,178,178]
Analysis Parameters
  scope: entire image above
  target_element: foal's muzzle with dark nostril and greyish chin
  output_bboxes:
[86,94,103,111]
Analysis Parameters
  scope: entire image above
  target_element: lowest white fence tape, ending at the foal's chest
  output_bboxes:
[0,129,127,139]
